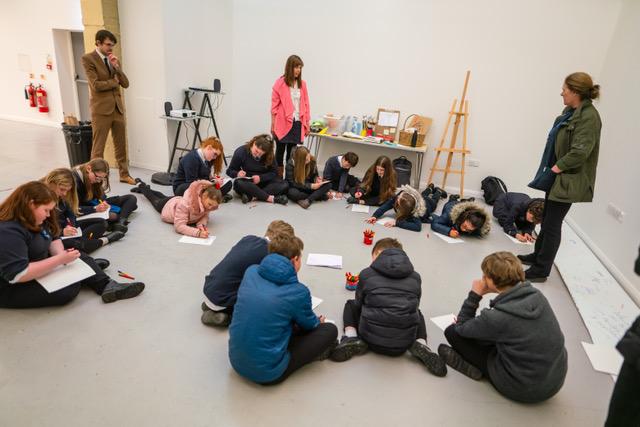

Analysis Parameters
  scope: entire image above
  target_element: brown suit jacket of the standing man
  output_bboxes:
[82,50,129,115]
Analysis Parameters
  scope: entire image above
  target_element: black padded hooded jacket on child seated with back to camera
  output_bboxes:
[356,248,422,354]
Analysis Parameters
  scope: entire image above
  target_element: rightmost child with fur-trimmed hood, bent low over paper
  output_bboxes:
[431,194,491,238]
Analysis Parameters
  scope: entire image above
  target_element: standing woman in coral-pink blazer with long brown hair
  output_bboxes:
[271,55,310,178]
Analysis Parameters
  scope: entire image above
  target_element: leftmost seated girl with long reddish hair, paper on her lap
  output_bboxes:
[0,181,144,308]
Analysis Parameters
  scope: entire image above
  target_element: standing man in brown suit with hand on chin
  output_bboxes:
[82,30,135,185]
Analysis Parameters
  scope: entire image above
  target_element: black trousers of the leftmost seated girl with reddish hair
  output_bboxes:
[0,253,111,308]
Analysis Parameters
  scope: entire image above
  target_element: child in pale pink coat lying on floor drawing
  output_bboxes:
[131,179,222,239]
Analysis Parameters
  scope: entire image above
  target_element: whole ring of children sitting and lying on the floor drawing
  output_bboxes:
[0,130,556,402]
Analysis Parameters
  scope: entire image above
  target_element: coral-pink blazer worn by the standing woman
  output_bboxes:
[271,76,311,142]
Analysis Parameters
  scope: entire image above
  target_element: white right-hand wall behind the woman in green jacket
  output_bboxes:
[570,0,640,301]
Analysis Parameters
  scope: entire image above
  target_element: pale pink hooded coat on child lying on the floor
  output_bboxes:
[161,179,213,237]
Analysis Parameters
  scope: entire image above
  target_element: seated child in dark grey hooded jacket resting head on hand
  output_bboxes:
[438,252,567,403]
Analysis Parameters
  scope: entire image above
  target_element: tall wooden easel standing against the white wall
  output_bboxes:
[427,71,471,197]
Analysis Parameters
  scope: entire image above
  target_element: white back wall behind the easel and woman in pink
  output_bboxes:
[229,0,620,194]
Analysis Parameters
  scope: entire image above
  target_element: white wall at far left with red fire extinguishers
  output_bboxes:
[0,0,83,127]
